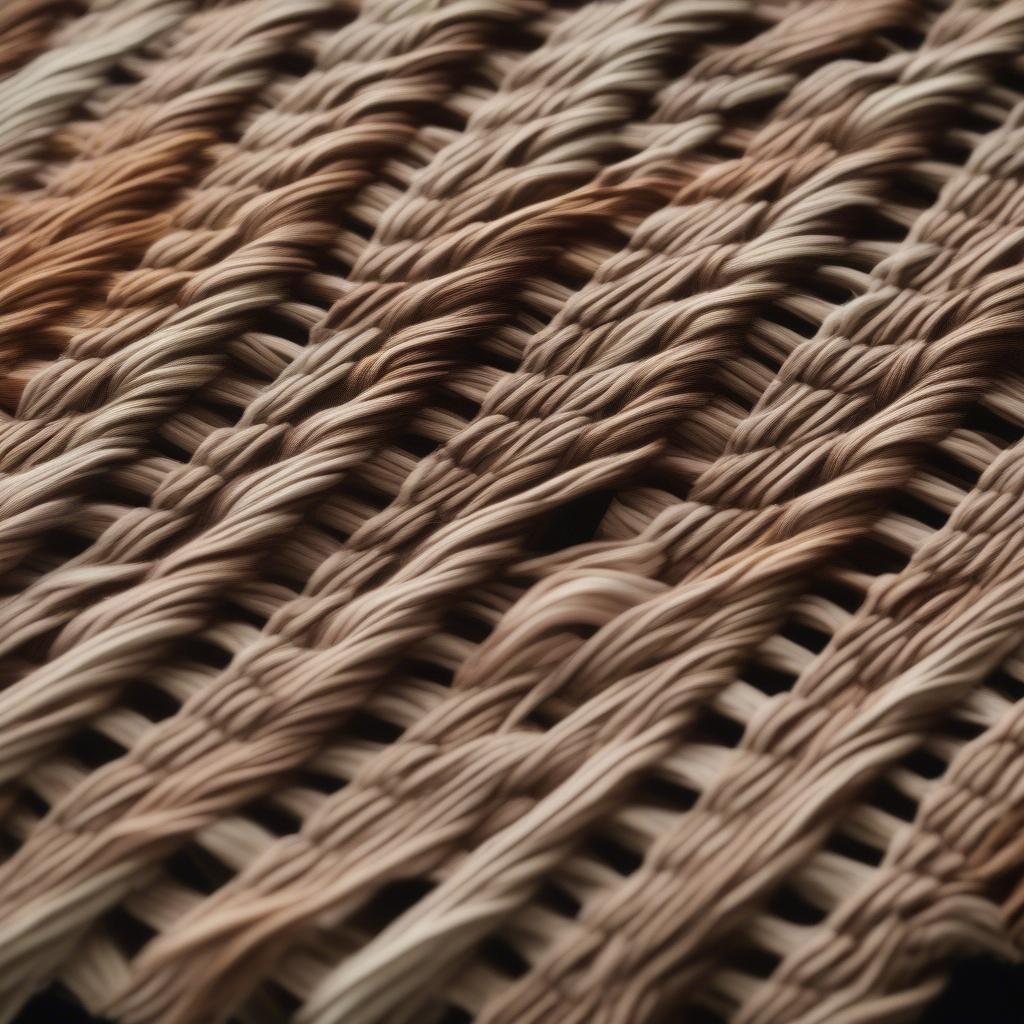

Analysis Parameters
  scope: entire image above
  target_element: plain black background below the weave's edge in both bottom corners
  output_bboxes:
[9,958,1024,1024]
